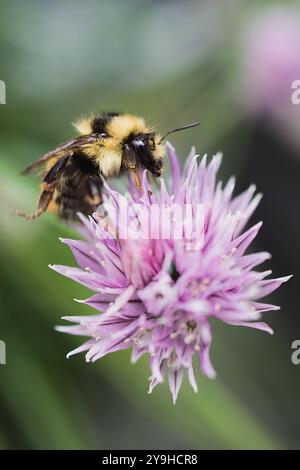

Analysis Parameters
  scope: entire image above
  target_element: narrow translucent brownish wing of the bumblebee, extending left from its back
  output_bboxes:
[22,135,98,175]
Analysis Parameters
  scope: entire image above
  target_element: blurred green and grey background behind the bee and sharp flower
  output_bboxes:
[0,0,300,449]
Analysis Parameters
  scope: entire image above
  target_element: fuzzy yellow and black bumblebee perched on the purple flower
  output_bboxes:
[17,112,198,220]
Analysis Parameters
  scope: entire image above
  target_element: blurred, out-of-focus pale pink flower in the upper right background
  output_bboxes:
[240,5,300,114]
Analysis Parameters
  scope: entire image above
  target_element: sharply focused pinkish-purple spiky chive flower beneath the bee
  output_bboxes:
[52,145,288,402]
